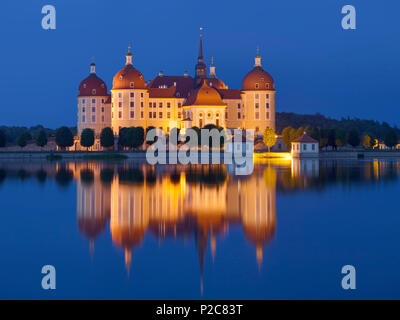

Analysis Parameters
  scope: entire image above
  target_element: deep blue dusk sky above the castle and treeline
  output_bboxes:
[0,0,400,128]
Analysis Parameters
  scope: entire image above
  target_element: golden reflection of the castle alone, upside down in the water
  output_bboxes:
[72,163,276,276]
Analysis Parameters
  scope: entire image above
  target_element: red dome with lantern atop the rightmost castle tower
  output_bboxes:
[242,49,274,90]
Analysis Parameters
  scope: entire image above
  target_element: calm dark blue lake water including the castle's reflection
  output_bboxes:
[0,160,400,299]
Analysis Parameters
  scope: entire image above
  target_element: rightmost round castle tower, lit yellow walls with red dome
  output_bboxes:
[242,48,275,135]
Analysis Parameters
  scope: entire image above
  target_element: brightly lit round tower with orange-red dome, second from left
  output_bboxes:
[111,46,149,134]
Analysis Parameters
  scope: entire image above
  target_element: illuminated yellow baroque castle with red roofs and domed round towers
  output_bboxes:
[78,35,276,148]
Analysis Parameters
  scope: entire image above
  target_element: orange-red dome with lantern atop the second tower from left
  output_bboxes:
[113,47,146,90]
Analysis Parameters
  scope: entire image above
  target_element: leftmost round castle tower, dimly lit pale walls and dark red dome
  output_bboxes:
[78,62,111,135]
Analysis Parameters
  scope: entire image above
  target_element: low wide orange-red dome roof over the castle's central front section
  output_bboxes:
[183,79,226,106]
